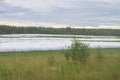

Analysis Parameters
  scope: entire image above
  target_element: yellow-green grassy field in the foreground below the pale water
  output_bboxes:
[0,49,120,80]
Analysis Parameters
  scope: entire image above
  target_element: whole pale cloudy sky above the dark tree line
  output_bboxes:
[0,0,120,28]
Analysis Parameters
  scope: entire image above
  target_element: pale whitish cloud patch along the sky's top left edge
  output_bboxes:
[4,0,75,12]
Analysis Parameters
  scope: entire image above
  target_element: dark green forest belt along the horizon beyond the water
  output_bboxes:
[0,25,120,36]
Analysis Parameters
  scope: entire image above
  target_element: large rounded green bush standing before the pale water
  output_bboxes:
[65,39,90,64]
